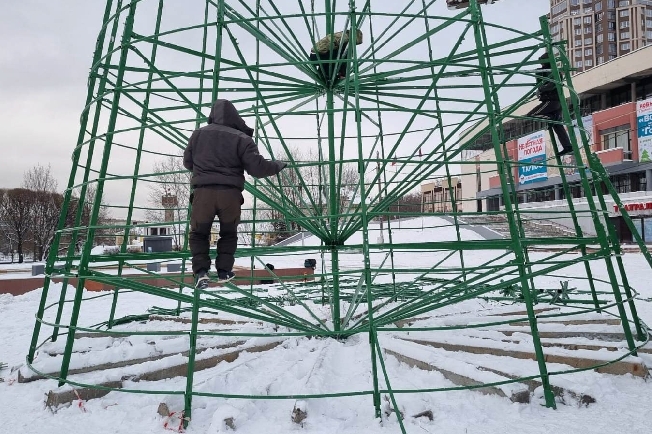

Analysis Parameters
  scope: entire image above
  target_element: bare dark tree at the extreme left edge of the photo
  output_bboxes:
[0,188,34,263]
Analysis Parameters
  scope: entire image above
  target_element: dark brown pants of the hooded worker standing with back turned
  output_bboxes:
[189,186,244,274]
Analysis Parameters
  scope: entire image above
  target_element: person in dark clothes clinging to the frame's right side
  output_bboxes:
[526,52,573,156]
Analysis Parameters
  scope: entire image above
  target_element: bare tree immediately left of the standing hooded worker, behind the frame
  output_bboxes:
[146,153,190,246]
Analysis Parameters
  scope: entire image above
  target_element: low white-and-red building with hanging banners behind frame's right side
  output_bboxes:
[461,45,652,243]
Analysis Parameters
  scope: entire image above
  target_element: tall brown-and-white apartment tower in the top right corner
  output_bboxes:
[550,0,652,72]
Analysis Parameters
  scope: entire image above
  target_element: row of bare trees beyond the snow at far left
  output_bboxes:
[0,165,108,263]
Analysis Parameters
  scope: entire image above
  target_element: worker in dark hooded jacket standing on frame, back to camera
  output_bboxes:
[183,99,287,289]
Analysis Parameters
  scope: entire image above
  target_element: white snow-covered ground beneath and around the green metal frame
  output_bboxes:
[0,218,652,434]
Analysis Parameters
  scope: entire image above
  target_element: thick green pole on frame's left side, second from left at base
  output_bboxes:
[59,1,137,386]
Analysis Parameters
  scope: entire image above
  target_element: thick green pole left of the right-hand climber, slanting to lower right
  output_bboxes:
[470,0,556,408]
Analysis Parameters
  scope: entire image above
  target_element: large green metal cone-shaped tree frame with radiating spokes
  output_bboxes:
[27,0,652,432]
